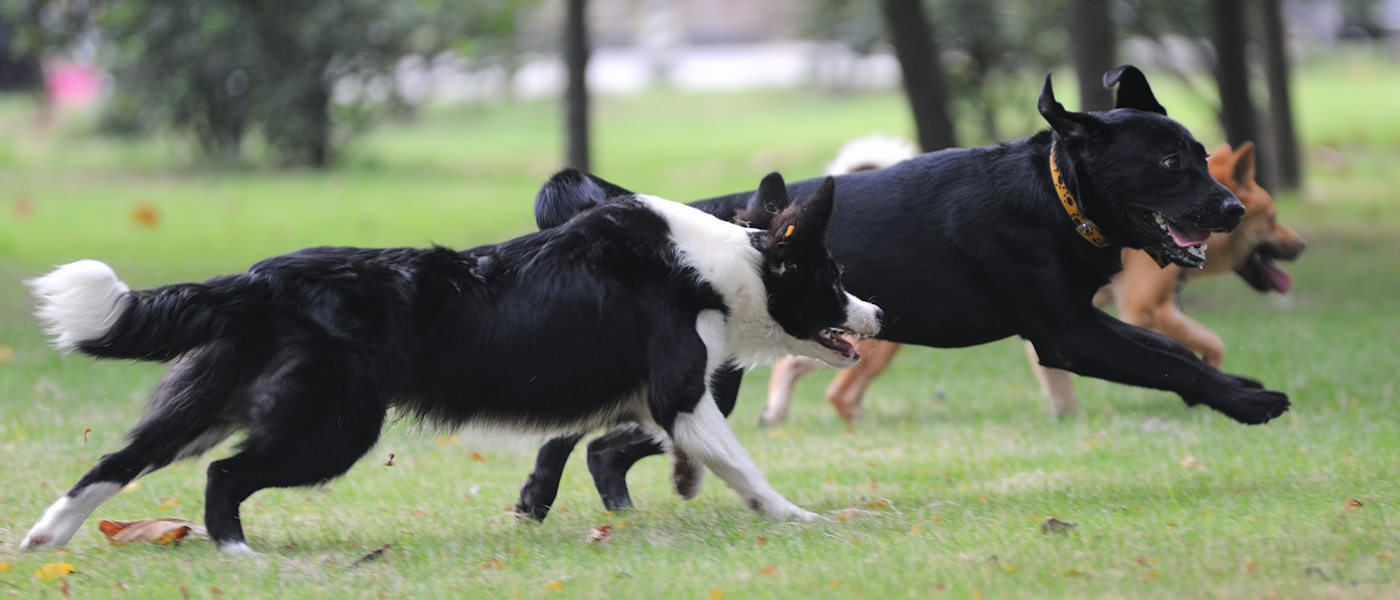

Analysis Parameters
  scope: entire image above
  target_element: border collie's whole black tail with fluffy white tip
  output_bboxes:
[25,260,263,361]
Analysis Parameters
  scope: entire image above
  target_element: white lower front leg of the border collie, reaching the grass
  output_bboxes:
[672,390,816,520]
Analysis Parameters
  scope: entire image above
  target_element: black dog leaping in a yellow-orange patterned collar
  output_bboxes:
[517,66,1288,519]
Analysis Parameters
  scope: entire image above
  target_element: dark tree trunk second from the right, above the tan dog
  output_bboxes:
[1210,0,1259,158]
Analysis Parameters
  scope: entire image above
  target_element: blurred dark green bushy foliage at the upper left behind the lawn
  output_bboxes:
[15,0,529,168]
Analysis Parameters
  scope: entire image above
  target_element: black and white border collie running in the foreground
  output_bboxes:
[20,172,879,554]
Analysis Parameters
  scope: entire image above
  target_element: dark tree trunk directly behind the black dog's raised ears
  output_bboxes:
[1065,0,1117,110]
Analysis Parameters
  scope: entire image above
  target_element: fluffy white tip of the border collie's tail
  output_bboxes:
[25,260,132,352]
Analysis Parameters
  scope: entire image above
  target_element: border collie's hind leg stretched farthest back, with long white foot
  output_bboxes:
[20,352,238,550]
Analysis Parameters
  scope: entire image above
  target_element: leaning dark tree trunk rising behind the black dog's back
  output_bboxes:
[883,0,958,152]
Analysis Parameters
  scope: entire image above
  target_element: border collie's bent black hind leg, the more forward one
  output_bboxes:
[204,354,389,554]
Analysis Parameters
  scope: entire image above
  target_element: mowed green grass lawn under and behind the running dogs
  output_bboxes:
[0,56,1400,599]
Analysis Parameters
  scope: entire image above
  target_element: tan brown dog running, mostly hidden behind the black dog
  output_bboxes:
[759,141,1308,425]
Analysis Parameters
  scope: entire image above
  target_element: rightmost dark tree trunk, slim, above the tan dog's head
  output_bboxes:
[1260,0,1302,190]
